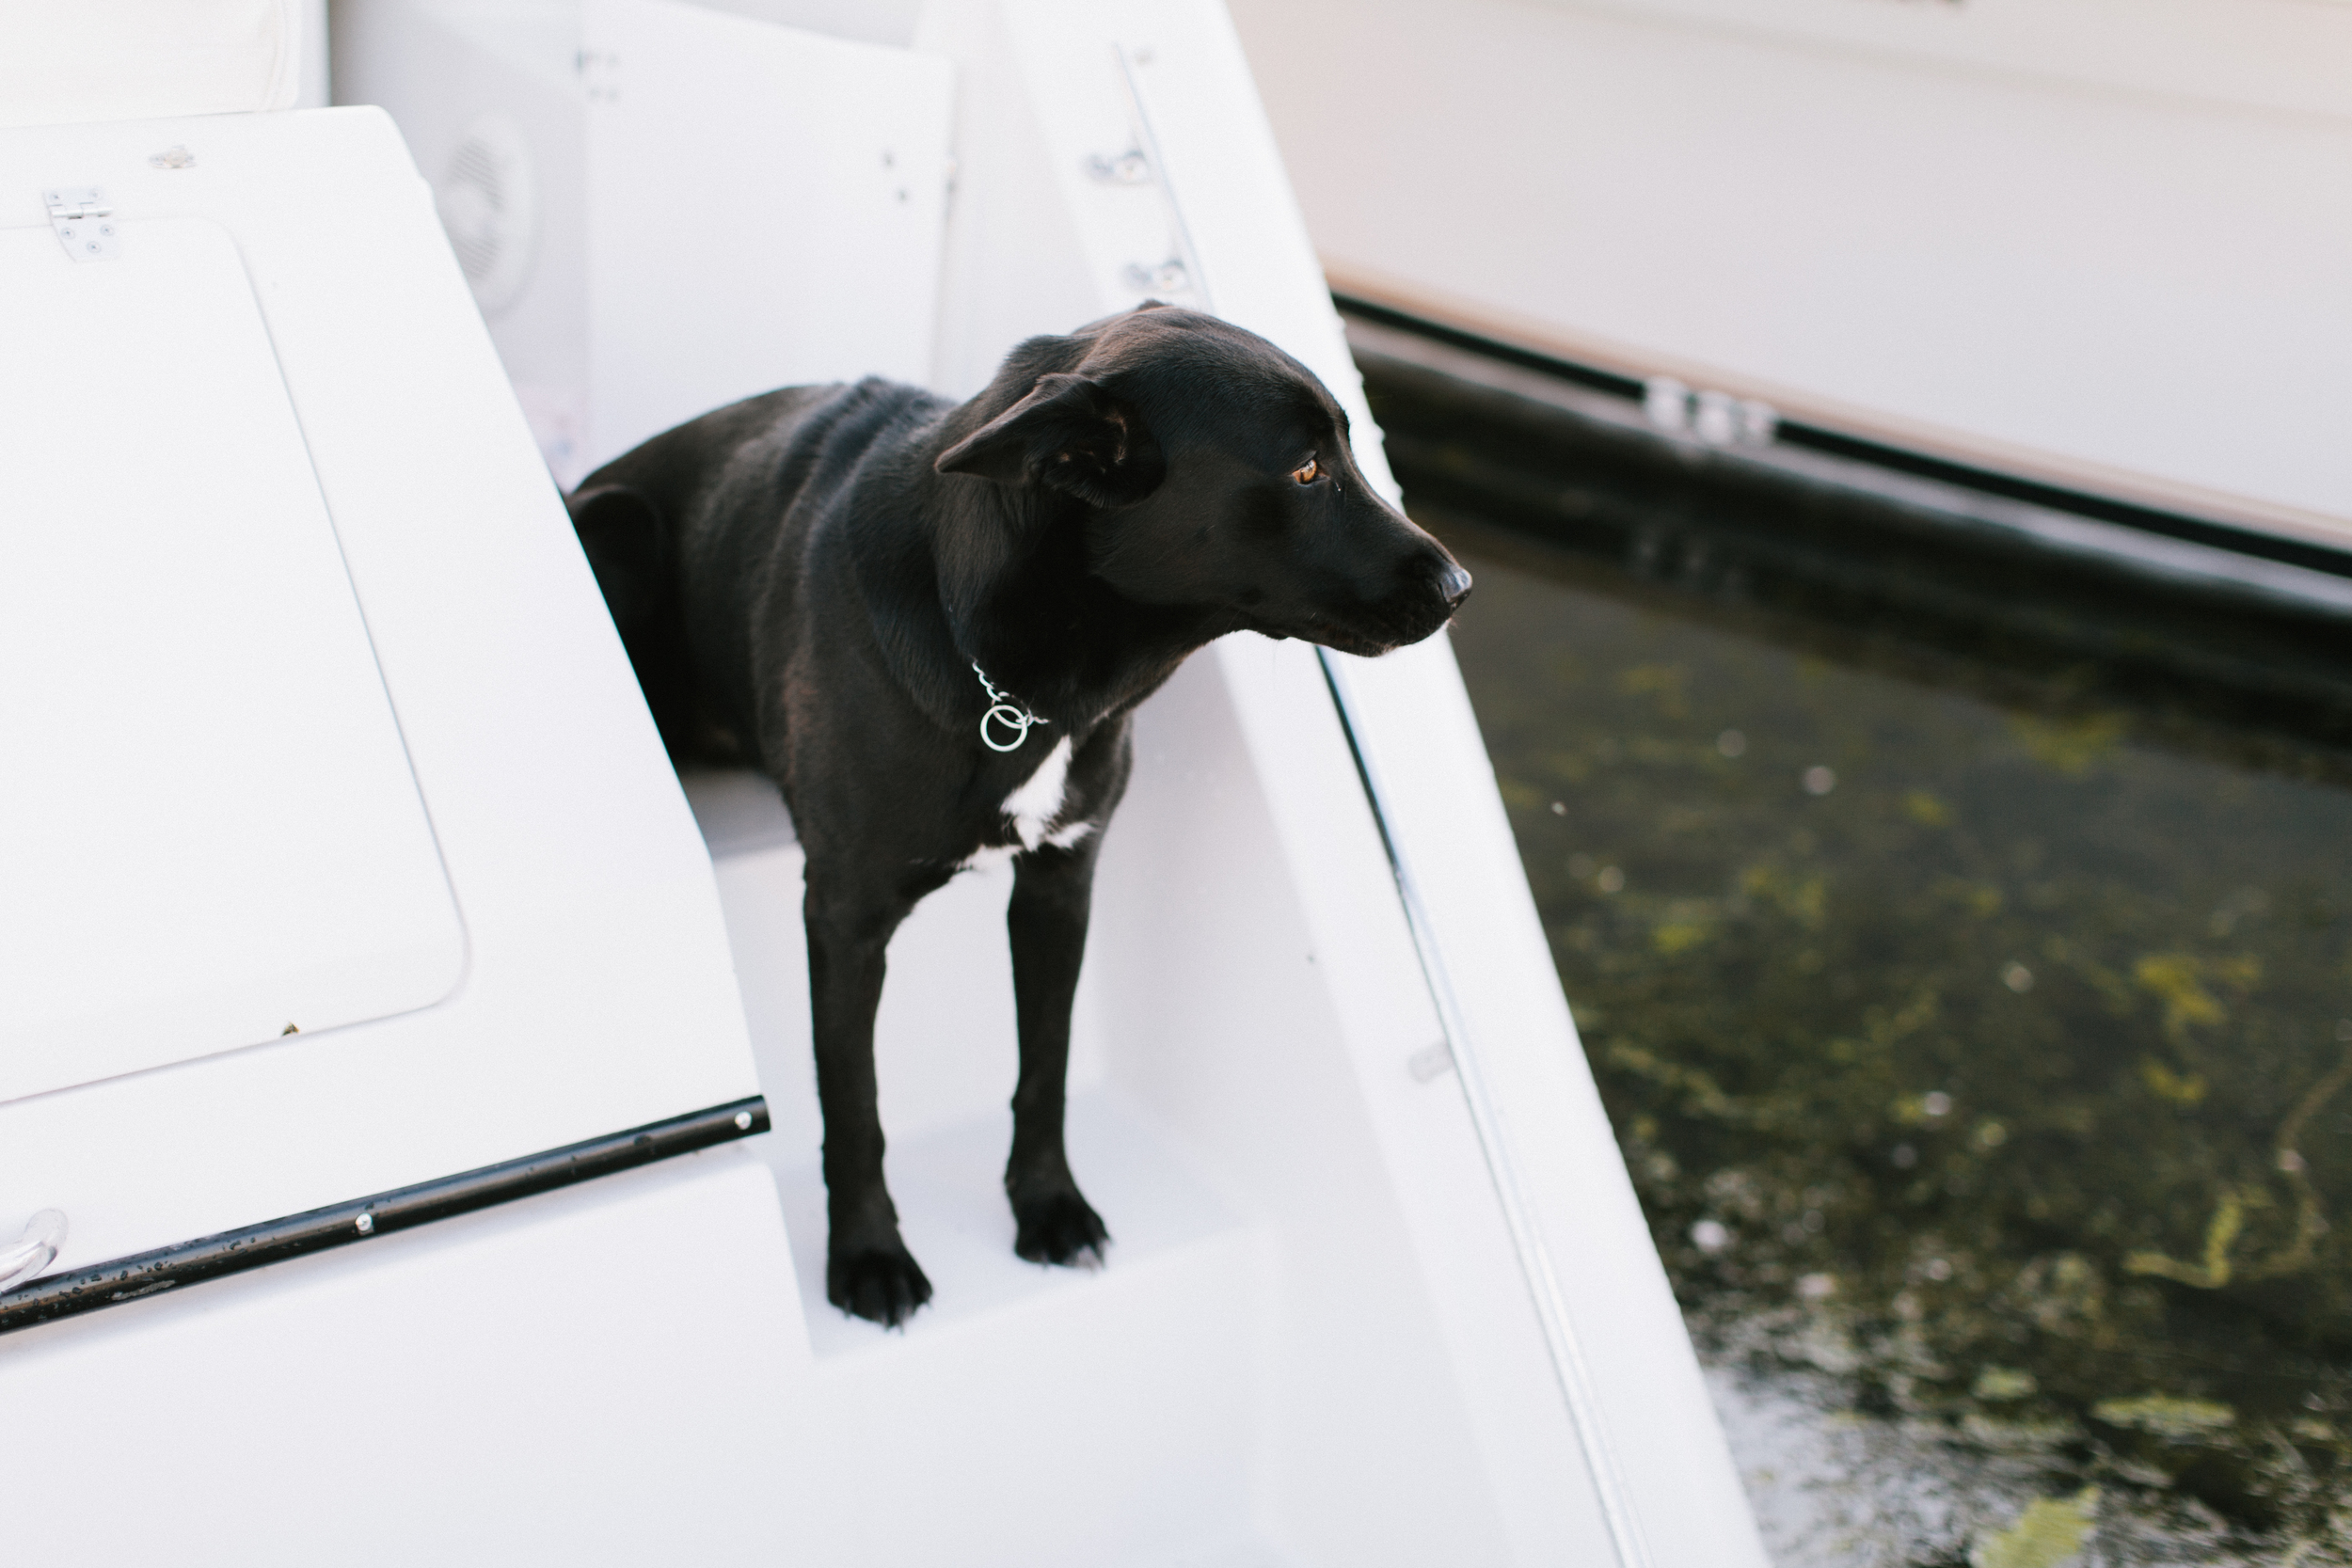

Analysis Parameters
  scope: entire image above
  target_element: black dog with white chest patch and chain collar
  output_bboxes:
[569,306,1470,1323]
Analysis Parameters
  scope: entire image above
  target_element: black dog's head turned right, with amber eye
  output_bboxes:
[939,306,1470,654]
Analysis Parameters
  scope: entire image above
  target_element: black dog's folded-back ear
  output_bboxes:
[936,373,1167,505]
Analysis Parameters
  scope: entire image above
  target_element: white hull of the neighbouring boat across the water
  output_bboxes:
[1232,0,2352,555]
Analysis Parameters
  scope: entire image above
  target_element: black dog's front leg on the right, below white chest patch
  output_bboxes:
[1005,837,1110,1262]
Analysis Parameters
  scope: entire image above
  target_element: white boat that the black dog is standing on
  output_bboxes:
[0,0,1762,1568]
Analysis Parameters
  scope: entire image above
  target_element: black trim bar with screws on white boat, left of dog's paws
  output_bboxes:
[0,1096,770,1333]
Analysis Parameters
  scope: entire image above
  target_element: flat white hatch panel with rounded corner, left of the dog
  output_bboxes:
[0,218,466,1101]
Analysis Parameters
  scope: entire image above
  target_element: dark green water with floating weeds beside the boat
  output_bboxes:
[1428,517,2352,1568]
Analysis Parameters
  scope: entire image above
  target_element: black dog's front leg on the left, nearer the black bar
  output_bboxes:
[803,867,931,1326]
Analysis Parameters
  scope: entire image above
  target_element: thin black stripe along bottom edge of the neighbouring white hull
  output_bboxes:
[1331,293,2352,578]
